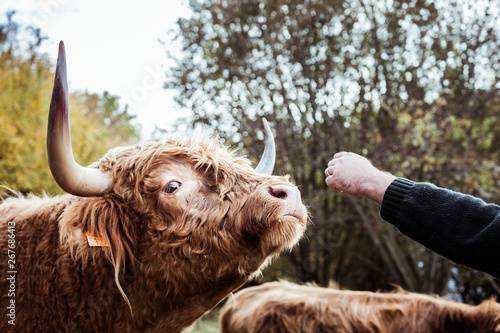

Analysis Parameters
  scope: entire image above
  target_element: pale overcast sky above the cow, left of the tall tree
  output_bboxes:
[0,0,190,139]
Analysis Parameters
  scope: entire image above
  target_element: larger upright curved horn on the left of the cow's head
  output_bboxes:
[47,41,111,197]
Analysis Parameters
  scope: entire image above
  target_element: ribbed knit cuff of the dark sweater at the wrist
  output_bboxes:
[380,178,415,226]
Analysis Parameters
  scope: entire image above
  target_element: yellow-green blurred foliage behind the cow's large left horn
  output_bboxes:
[0,14,138,194]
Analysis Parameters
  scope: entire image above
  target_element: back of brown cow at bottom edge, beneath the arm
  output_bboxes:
[220,282,500,333]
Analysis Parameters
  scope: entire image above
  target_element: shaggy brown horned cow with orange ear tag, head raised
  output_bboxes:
[0,43,307,333]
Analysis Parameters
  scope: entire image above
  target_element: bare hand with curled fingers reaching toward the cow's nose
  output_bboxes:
[325,152,396,205]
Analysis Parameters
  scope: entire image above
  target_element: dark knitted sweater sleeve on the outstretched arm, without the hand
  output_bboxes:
[380,178,500,278]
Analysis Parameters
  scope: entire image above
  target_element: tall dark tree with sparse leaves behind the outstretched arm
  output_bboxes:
[167,0,500,301]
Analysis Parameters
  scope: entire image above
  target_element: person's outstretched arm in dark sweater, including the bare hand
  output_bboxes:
[325,153,500,277]
